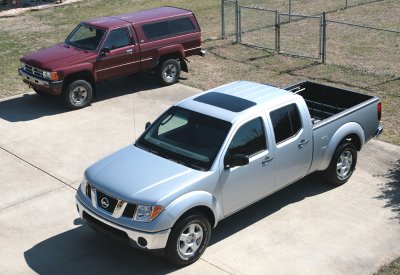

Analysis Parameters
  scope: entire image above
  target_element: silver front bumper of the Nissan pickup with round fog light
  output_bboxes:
[75,196,171,250]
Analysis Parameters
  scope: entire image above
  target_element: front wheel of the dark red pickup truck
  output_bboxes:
[63,80,93,110]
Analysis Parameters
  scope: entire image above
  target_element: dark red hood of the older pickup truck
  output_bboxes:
[21,44,97,70]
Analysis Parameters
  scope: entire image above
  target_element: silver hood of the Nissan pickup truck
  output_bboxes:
[85,145,207,204]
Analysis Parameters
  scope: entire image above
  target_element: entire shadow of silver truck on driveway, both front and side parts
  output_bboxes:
[24,175,332,274]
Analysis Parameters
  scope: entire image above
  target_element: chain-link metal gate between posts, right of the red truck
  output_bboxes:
[221,0,326,63]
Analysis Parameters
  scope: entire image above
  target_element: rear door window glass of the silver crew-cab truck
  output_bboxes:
[270,103,302,144]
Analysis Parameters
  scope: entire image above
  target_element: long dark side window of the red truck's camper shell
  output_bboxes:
[142,17,195,40]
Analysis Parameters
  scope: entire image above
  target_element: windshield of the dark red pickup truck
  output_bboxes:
[65,24,106,51]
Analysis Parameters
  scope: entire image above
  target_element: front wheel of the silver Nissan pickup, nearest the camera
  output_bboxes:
[165,213,211,265]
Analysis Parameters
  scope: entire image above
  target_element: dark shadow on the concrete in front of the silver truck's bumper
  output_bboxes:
[24,222,177,274]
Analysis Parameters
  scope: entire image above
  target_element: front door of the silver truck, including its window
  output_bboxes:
[220,117,274,216]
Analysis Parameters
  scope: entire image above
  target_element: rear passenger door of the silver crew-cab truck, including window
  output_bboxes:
[269,103,312,189]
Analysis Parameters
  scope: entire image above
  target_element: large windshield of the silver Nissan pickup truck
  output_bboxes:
[135,106,231,170]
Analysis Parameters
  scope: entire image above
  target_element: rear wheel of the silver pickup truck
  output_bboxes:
[325,142,357,186]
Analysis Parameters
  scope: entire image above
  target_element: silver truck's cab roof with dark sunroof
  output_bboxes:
[177,81,298,123]
